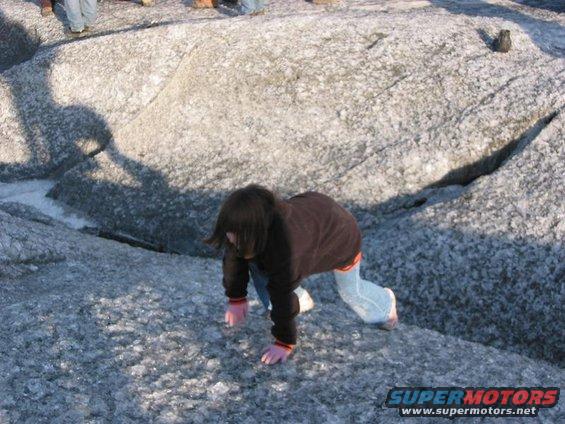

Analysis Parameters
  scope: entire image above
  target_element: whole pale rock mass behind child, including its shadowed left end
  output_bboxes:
[0,1,565,254]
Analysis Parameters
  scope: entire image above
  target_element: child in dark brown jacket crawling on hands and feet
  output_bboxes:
[205,185,398,364]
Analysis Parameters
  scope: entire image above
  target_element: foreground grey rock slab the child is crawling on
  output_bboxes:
[0,215,564,423]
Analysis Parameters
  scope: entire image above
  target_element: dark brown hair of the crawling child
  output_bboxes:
[204,184,280,255]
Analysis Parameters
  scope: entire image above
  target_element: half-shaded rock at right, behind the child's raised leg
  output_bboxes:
[364,112,565,366]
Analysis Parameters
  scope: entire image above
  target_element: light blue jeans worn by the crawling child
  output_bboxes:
[249,262,392,324]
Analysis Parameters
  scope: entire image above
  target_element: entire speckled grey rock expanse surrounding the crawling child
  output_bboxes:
[0,0,565,424]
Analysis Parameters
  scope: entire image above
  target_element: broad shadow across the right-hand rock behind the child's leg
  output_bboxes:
[361,220,565,367]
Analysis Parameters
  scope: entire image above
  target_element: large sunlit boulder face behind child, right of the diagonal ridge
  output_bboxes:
[41,8,563,254]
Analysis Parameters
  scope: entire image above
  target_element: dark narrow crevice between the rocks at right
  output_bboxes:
[426,112,557,189]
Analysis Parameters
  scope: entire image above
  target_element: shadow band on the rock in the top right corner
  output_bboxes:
[431,0,565,58]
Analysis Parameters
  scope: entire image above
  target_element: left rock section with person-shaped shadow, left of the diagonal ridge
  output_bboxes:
[0,19,194,182]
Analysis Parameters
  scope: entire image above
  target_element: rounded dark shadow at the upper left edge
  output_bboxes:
[0,10,40,72]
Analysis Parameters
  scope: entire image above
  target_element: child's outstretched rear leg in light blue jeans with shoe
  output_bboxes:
[334,262,396,329]
